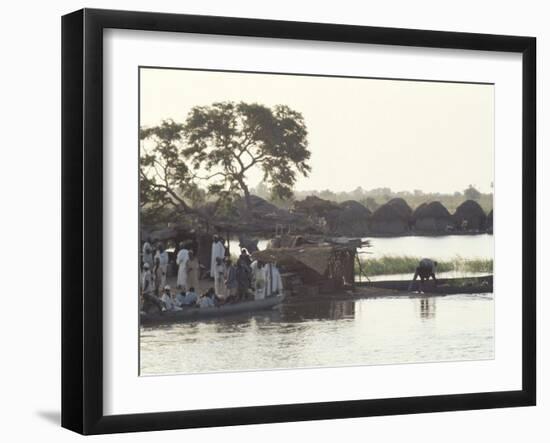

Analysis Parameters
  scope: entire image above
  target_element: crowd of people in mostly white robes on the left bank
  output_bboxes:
[141,235,283,311]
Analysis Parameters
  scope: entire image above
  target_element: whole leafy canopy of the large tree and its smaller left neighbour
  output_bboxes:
[140,102,311,224]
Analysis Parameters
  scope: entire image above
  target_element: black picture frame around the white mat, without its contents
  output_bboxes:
[62,9,536,434]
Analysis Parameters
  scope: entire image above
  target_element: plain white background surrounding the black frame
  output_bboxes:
[0,0,550,443]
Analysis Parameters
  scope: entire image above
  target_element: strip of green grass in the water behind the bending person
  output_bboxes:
[356,255,493,276]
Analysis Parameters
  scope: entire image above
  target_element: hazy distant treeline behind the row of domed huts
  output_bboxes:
[252,183,493,213]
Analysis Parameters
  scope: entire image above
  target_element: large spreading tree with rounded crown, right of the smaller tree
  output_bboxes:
[183,102,311,212]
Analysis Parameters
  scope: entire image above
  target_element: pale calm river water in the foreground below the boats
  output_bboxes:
[141,294,494,375]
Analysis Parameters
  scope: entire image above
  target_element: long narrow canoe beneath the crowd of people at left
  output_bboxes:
[140,295,285,326]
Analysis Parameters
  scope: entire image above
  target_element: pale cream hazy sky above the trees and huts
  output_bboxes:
[140,68,494,192]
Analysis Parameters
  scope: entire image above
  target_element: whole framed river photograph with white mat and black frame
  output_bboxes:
[62,9,536,434]
